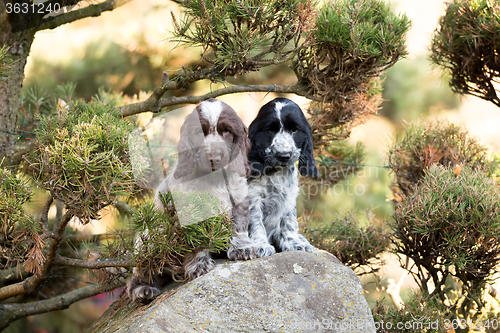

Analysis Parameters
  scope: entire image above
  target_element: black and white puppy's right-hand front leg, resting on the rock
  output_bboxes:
[273,210,314,252]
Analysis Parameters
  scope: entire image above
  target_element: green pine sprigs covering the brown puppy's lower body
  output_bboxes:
[128,192,232,271]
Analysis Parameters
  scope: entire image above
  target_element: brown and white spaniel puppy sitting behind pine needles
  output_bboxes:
[127,99,257,303]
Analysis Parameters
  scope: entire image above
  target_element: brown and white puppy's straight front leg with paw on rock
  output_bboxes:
[227,198,257,260]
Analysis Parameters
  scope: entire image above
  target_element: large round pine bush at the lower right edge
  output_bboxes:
[391,165,500,318]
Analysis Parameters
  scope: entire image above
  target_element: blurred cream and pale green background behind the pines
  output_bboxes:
[6,0,500,333]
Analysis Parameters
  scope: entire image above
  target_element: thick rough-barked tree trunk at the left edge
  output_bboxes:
[0,1,37,166]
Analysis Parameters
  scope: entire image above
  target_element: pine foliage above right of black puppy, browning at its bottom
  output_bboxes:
[292,0,411,136]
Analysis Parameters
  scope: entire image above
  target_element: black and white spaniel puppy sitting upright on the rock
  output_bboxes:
[248,98,318,257]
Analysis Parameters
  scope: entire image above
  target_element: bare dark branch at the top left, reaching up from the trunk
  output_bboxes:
[38,0,132,31]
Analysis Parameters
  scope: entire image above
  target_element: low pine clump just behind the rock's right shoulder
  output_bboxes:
[303,212,391,273]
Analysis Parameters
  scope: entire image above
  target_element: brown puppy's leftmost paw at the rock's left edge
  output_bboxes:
[127,267,161,304]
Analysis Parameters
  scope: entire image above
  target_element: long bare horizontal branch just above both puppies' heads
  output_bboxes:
[118,84,321,117]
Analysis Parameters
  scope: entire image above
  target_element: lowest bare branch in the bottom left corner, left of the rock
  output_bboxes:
[0,279,126,331]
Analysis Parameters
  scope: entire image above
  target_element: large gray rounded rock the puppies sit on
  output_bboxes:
[89,250,375,333]
